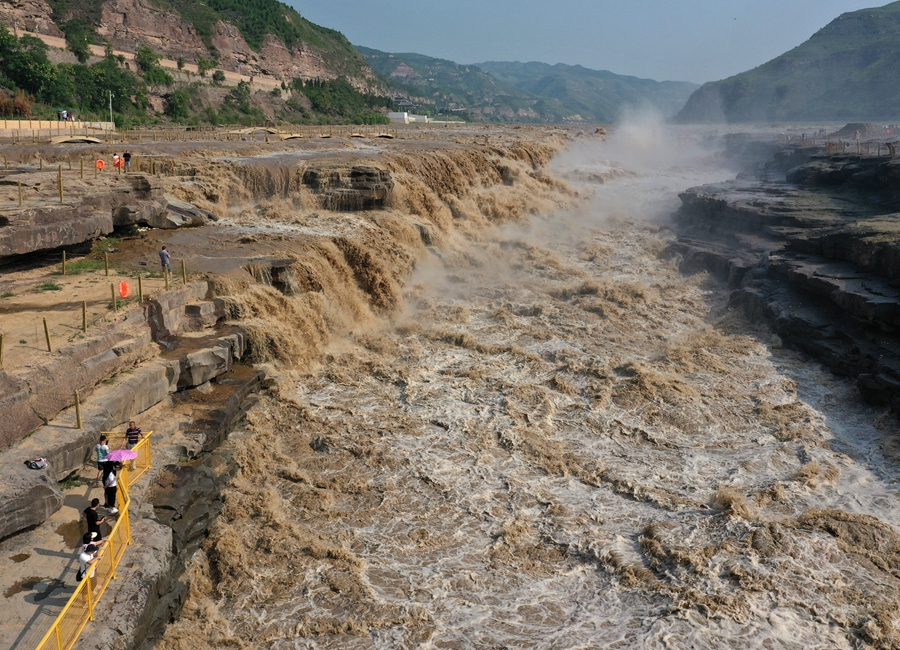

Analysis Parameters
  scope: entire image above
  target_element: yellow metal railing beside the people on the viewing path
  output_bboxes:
[36,431,153,650]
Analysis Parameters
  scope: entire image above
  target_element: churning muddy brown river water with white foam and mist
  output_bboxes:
[157,124,900,649]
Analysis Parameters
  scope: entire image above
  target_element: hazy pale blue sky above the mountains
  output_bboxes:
[286,0,887,83]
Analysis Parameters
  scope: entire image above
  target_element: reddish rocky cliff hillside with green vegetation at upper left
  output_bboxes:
[0,0,377,88]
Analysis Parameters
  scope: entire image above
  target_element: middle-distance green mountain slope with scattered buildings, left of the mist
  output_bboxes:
[356,46,561,122]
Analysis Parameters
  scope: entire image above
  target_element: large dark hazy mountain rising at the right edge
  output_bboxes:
[676,2,900,122]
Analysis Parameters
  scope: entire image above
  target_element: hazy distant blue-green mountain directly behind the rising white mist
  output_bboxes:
[477,61,698,122]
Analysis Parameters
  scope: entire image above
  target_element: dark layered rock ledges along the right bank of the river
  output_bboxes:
[669,149,900,410]
